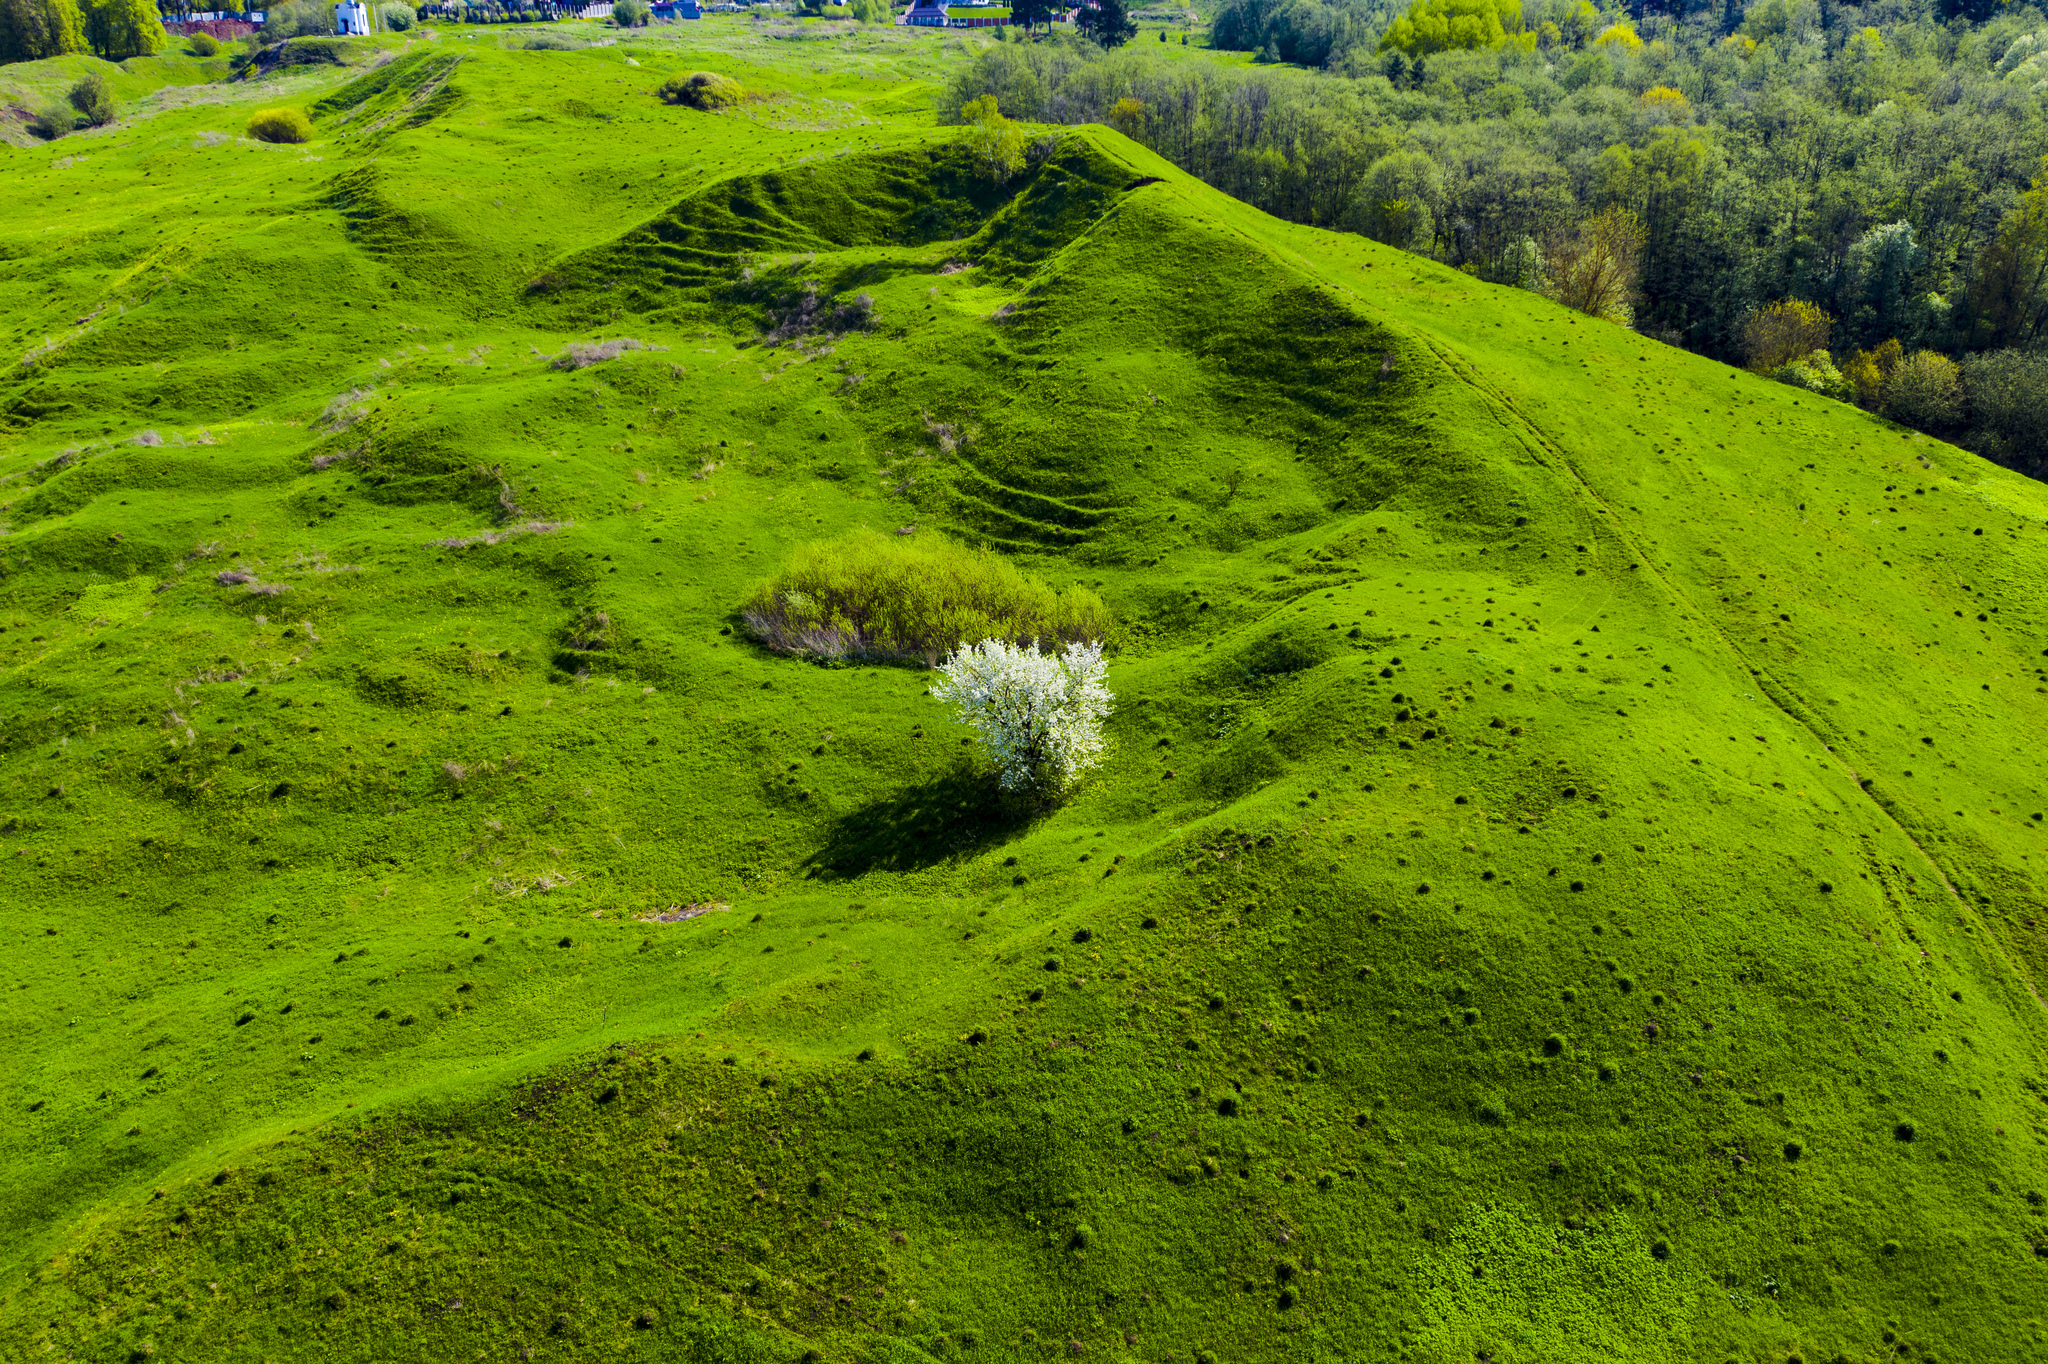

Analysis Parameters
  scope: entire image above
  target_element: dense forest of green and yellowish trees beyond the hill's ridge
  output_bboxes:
[942,0,2048,475]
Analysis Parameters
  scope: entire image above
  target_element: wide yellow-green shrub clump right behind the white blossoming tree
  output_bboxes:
[741,530,1110,666]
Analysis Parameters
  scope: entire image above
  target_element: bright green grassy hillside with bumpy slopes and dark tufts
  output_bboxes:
[0,25,2048,1360]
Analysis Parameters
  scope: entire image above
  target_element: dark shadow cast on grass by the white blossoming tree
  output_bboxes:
[805,764,1030,881]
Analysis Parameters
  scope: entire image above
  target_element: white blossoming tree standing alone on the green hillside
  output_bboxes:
[932,639,1112,801]
